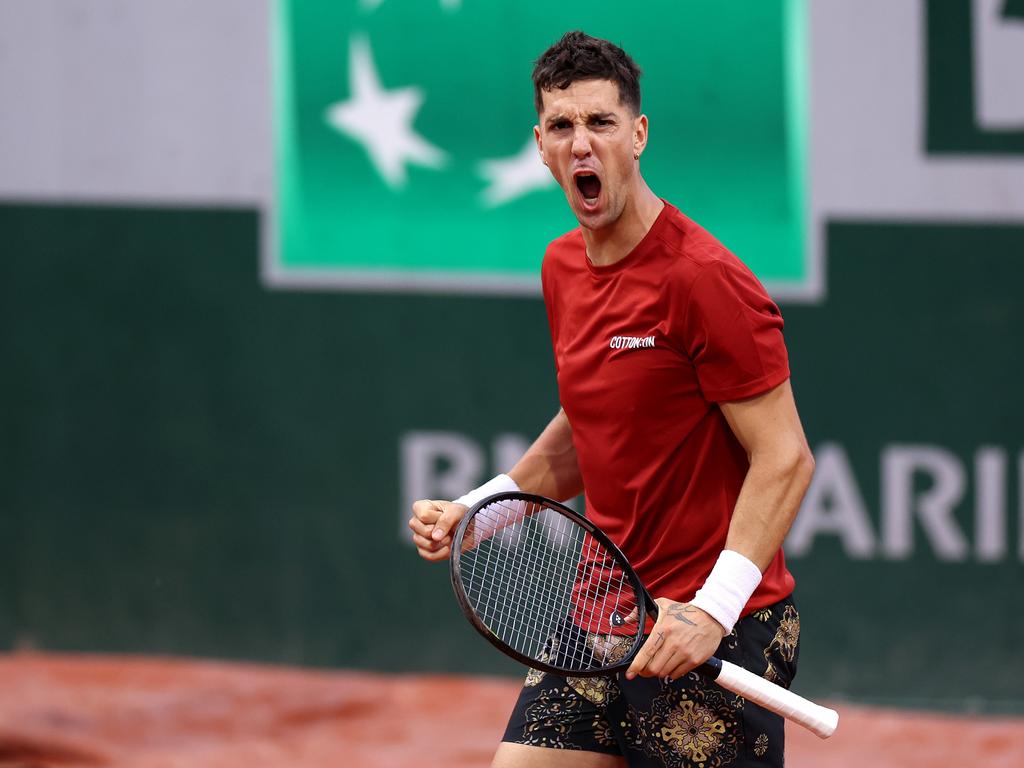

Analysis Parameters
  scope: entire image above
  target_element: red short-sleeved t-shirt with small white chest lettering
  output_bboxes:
[542,203,794,613]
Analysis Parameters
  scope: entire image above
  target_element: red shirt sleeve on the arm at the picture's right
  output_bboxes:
[682,257,790,402]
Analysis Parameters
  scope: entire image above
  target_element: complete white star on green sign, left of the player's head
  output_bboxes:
[327,37,446,188]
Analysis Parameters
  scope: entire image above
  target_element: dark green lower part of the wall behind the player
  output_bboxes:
[0,204,1024,711]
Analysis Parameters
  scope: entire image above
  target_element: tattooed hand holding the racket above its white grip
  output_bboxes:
[626,597,725,680]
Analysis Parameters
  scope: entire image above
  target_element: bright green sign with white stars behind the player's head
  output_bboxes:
[267,0,811,298]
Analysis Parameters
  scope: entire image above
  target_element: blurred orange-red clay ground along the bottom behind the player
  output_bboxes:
[0,653,1024,768]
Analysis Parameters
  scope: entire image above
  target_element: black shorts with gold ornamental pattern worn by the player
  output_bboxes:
[503,598,800,768]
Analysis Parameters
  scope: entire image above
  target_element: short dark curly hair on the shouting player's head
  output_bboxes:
[534,30,641,115]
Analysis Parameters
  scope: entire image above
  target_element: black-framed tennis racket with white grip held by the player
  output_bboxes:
[450,493,839,738]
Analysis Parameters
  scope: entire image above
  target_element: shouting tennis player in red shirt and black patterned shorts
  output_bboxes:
[410,32,814,768]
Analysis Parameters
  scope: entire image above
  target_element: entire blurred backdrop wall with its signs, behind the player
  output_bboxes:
[0,0,1024,765]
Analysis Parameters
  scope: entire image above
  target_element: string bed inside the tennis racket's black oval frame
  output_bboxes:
[458,500,640,672]
